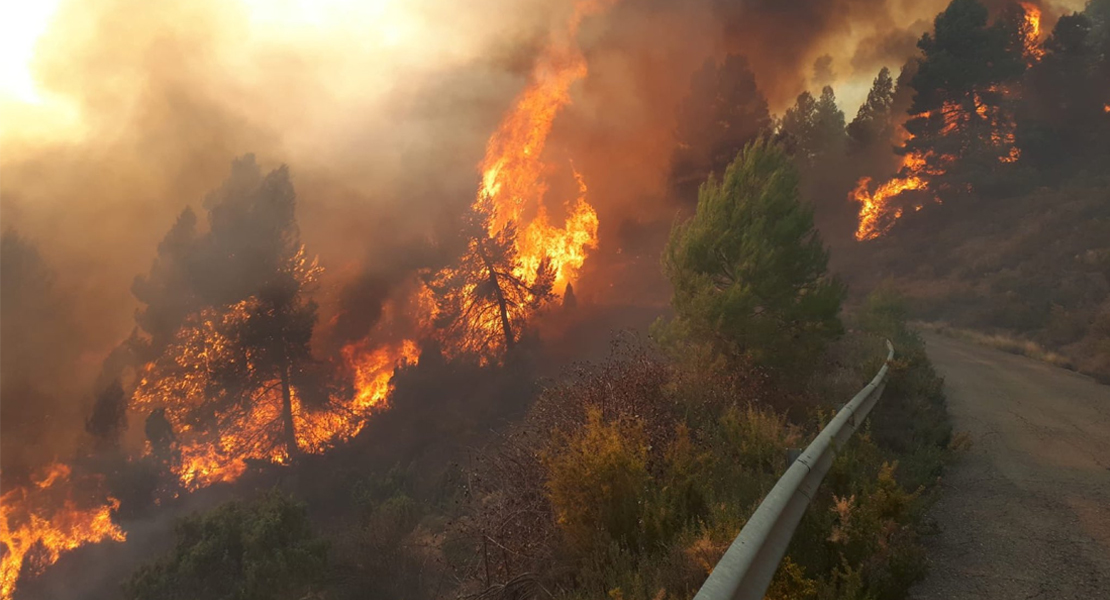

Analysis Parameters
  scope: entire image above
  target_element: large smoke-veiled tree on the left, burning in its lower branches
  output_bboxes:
[134,156,331,485]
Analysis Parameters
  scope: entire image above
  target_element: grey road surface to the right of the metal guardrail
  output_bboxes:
[912,335,1110,600]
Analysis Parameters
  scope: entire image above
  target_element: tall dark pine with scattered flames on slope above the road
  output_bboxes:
[851,0,1041,240]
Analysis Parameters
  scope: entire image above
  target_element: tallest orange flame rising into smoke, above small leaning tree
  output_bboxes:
[475,0,614,294]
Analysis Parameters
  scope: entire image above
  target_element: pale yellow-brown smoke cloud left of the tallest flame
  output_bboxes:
[0,0,551,472]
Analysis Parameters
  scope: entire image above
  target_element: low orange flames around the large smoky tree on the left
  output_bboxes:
[133,299,417,490]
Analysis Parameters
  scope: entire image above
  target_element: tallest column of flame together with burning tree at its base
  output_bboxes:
[417,0,615,364]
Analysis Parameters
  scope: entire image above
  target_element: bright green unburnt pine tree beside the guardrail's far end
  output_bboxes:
[657,141,844,372]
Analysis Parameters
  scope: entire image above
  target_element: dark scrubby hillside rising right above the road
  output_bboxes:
[844,176,1110,380]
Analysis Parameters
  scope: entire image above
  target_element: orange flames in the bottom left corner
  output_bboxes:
[0,462,127,600]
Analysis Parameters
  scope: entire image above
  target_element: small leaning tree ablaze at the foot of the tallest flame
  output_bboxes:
[426,203,555,358]
